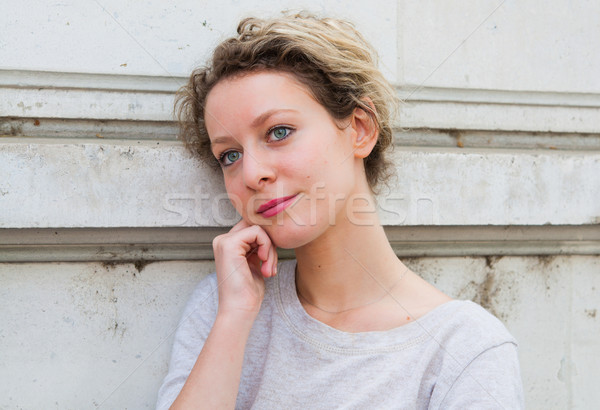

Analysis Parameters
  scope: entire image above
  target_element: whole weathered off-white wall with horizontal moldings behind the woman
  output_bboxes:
[0,0,600,409]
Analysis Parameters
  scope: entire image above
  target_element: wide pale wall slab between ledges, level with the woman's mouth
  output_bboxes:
[0,139,600,228]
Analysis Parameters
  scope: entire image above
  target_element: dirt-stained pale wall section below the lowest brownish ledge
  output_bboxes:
[0,256,600,409]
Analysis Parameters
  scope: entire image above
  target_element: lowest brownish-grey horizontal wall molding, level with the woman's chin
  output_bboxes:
[0,225,600,265]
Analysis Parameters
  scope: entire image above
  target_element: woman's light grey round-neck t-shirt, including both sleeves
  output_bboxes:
[157,260,523,409]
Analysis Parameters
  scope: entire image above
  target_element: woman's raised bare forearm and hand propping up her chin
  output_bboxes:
[171,219,277,409]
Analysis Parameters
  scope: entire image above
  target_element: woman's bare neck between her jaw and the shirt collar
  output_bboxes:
[295,194,406,313]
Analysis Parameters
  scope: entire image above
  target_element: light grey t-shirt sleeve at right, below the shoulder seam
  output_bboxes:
[439,342,524,410]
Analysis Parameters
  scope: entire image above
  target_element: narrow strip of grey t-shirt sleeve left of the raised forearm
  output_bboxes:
[156,274,218,410]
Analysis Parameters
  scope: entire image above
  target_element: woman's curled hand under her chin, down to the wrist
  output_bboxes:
[213,219,277,320]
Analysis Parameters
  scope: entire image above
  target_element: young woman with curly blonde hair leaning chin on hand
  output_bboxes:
[158,11,523,409]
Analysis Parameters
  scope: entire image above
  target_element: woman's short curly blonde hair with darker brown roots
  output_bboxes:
[175,13,397,192]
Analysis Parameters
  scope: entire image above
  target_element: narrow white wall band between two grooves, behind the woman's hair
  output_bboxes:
[0,70,600,133]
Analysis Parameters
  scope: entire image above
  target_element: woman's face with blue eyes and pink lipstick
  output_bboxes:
[205,71,364,249]
